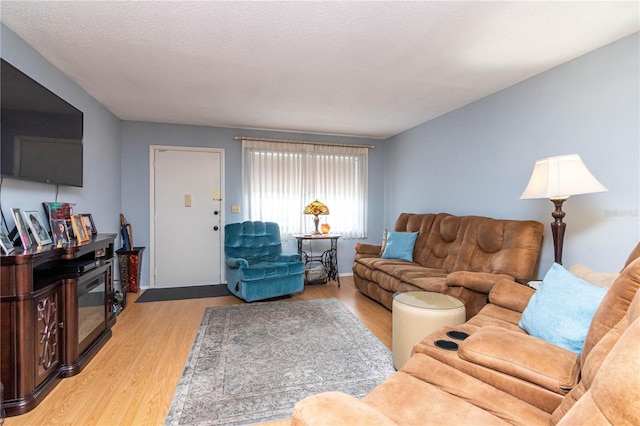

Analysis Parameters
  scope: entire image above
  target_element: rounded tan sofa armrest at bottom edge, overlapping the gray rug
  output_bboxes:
[291,392,396,426]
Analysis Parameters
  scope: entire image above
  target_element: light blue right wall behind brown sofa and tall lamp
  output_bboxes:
[385,33,640,273]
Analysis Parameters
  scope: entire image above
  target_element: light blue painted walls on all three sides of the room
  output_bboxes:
[0,20,640,286]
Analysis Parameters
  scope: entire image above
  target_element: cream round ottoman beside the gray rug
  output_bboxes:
[392,291,466,370]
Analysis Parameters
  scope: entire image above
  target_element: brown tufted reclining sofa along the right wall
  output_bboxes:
[353,213,544,318]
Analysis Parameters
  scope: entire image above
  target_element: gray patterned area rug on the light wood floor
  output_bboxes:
[165,299,395,425]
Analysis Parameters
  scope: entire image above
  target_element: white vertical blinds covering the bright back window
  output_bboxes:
[242,140,368,238]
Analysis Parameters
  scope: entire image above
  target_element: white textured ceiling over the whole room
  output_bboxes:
[0,0,640,138]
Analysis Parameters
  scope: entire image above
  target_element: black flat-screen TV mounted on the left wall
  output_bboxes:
[0,59,83,187]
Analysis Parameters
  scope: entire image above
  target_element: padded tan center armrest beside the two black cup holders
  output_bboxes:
[458,326,580,395]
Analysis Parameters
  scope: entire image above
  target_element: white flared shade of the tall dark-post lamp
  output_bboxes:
[520,154,607,199]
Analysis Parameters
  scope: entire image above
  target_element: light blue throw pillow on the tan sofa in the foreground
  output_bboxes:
[518,263,607,355]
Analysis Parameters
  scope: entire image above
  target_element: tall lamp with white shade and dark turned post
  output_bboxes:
[520,154,607,264]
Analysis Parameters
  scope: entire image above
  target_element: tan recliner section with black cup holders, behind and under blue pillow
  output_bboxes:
[413,244,640,413]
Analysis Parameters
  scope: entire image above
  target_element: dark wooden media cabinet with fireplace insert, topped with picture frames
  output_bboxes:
[0,234,116,416]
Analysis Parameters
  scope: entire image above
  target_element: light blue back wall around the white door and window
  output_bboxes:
[122,121,384,286]
